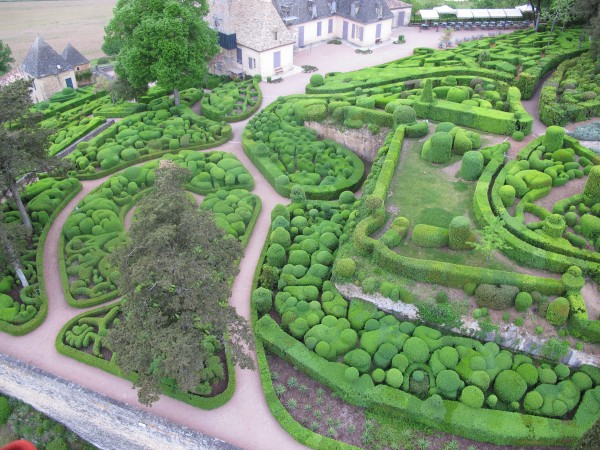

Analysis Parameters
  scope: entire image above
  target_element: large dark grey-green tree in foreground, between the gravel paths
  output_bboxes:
[107,162,253,404]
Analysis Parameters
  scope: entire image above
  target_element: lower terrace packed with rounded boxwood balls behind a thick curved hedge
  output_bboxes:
[252,195,599,445]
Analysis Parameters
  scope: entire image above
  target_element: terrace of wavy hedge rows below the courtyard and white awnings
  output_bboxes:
[306,29,589,99]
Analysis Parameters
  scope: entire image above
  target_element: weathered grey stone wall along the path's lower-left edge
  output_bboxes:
[0,355,237,450]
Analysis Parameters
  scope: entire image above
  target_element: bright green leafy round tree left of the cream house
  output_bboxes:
[103,0,219,105]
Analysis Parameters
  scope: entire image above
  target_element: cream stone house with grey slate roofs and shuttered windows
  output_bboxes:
[207,0,410,77]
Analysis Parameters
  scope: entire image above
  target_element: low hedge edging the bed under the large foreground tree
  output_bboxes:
[55,302,236,409]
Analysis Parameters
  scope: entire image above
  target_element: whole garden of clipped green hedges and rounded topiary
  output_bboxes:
[0,23,600,449]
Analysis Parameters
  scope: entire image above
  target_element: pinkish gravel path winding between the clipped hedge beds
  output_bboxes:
[0,28,588,450]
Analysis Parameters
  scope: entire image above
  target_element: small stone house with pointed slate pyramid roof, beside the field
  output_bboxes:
[21,35,79,103]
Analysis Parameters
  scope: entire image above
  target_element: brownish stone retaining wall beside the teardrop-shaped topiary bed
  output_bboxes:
[304,122,389,162]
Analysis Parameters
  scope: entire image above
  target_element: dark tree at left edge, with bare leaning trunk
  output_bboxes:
[0,80,55,233]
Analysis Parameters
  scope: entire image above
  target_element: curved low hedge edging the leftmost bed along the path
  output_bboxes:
[0,179,82,336]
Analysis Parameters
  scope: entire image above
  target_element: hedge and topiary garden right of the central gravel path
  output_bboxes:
[244,30,600,448]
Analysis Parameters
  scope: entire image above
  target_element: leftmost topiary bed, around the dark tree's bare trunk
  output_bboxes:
[0,178,81,335]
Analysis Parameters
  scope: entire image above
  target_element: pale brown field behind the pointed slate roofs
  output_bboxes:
[0,0,117,64]
